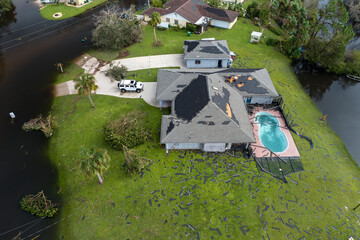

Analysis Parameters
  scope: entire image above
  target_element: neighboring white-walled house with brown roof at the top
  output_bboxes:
[142,0,239,33]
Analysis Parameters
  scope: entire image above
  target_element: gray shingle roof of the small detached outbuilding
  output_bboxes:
[184,40,231,60]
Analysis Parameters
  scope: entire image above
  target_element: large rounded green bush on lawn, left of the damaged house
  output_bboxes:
[104,111,148,150]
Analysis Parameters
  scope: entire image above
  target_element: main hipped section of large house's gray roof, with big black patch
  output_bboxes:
[159,70,255,143]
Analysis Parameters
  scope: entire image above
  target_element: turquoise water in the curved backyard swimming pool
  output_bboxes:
[255,112,288,153]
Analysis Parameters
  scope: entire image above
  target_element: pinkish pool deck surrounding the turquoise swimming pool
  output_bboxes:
[249,107,300,159]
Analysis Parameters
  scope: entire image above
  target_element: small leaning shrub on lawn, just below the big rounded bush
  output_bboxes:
[123,146,150,174]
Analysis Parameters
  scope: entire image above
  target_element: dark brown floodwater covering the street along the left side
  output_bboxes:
[0,0,144,239]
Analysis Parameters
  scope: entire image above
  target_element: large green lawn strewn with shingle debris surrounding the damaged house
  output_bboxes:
[49,19,360,239]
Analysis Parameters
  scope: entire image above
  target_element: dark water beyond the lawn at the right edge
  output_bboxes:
[297,71,360,166]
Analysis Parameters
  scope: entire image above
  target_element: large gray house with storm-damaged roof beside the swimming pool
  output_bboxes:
[156,69,278,152]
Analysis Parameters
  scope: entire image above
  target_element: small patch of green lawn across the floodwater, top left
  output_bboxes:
[40,0,107,20]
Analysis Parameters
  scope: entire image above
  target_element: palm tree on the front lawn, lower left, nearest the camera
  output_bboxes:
[78,147,111,184]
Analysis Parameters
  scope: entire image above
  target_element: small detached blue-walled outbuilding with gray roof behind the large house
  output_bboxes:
[184,40,232,68]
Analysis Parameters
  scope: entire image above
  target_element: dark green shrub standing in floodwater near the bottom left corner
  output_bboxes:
[20,191,58,218]
